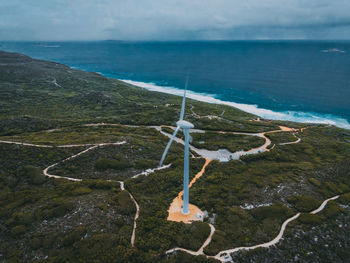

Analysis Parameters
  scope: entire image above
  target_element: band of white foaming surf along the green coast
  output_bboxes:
[119,79,350,130]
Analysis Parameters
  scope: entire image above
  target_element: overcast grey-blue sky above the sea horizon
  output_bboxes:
[0,0,350,41]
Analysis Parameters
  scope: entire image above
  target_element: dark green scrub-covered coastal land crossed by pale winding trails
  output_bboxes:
[0,51,350,262]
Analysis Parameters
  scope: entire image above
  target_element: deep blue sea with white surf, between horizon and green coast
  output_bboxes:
[0,41,350,129]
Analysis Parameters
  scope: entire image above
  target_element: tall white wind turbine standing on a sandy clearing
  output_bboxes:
[159,79,194,215]
